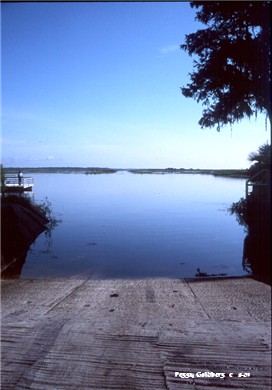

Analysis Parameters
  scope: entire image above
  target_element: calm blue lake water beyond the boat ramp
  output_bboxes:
[21,171,245,279]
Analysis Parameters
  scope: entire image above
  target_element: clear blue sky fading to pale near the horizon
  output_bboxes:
[1,2,270,168]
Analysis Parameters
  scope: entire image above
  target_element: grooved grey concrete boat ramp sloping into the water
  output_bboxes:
[1,278,271,390]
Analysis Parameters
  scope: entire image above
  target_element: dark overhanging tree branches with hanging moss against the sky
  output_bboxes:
[181,1,272,131]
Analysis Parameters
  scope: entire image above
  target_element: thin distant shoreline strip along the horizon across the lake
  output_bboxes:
[5,167,249,179]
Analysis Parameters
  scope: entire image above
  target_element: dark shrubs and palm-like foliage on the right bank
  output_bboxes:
[229,144,271,284]
